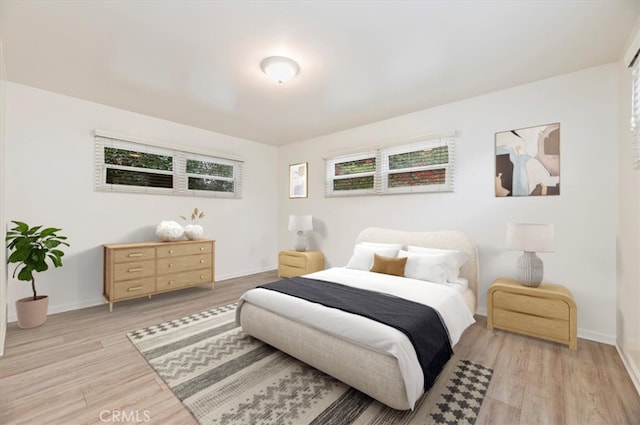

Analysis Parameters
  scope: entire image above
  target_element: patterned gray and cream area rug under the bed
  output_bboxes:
[127,305,492,425]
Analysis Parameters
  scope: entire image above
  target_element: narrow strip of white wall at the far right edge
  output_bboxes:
[616,20,640,392]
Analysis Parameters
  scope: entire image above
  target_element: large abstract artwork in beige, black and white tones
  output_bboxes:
[495,123,560,197]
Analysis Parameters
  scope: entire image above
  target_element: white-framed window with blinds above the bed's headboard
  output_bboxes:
[326,138,454,196]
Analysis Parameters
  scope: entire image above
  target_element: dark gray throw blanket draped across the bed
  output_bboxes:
[259,277,453,391]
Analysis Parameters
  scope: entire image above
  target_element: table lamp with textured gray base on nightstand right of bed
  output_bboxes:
[507,223,554,287]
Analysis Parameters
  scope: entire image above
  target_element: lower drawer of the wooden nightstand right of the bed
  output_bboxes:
[493,308,569,344]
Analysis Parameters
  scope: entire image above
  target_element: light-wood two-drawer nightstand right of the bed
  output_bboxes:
[487,278,578,350]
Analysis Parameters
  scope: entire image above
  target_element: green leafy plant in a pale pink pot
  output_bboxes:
[6,221,69,328]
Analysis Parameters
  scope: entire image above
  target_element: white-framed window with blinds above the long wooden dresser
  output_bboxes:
[95,130,242,198]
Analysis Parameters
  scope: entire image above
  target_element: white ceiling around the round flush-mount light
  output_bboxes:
[0,0,640,145]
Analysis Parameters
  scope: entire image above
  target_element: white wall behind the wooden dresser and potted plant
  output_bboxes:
[5,82,278,320]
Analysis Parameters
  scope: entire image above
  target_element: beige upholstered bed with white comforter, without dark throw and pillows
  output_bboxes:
[236,228,479,410]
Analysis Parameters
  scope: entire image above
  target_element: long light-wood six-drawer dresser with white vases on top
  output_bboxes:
[104,240,215,311]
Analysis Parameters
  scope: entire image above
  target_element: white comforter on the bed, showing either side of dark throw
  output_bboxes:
[238,267,475,406]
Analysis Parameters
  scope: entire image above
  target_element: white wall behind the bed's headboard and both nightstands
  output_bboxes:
[278,64,618,343]
